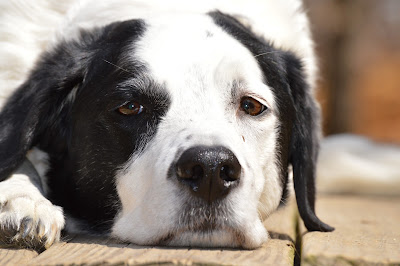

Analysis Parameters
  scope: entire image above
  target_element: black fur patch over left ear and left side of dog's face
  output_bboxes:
[0,20,170,232]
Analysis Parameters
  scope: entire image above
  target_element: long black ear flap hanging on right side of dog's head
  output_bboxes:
[285,53,334,231]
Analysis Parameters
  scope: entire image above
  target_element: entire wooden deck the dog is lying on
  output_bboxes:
[0,196,400,265]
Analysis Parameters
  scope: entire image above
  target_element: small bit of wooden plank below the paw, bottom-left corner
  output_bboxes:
[0,248,38,266]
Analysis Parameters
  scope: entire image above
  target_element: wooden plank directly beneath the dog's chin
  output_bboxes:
[31,201,296,265]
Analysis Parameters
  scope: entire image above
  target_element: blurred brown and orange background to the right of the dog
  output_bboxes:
[304,0,400,144]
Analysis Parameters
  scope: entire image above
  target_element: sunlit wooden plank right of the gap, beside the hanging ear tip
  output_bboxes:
[302,195,400,265]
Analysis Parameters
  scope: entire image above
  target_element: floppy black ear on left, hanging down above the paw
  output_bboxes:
[0,44,84,181]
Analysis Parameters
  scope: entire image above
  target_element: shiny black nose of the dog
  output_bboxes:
[176,146,241,203]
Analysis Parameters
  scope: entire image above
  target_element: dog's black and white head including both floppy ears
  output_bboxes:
[0,12,332,248]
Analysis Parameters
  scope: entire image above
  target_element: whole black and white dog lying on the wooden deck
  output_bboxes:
[0,0,333,249]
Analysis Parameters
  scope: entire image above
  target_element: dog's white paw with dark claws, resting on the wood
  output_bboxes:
[0,193,65,251]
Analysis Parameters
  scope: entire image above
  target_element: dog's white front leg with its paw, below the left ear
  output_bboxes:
[0,160,65,251]
